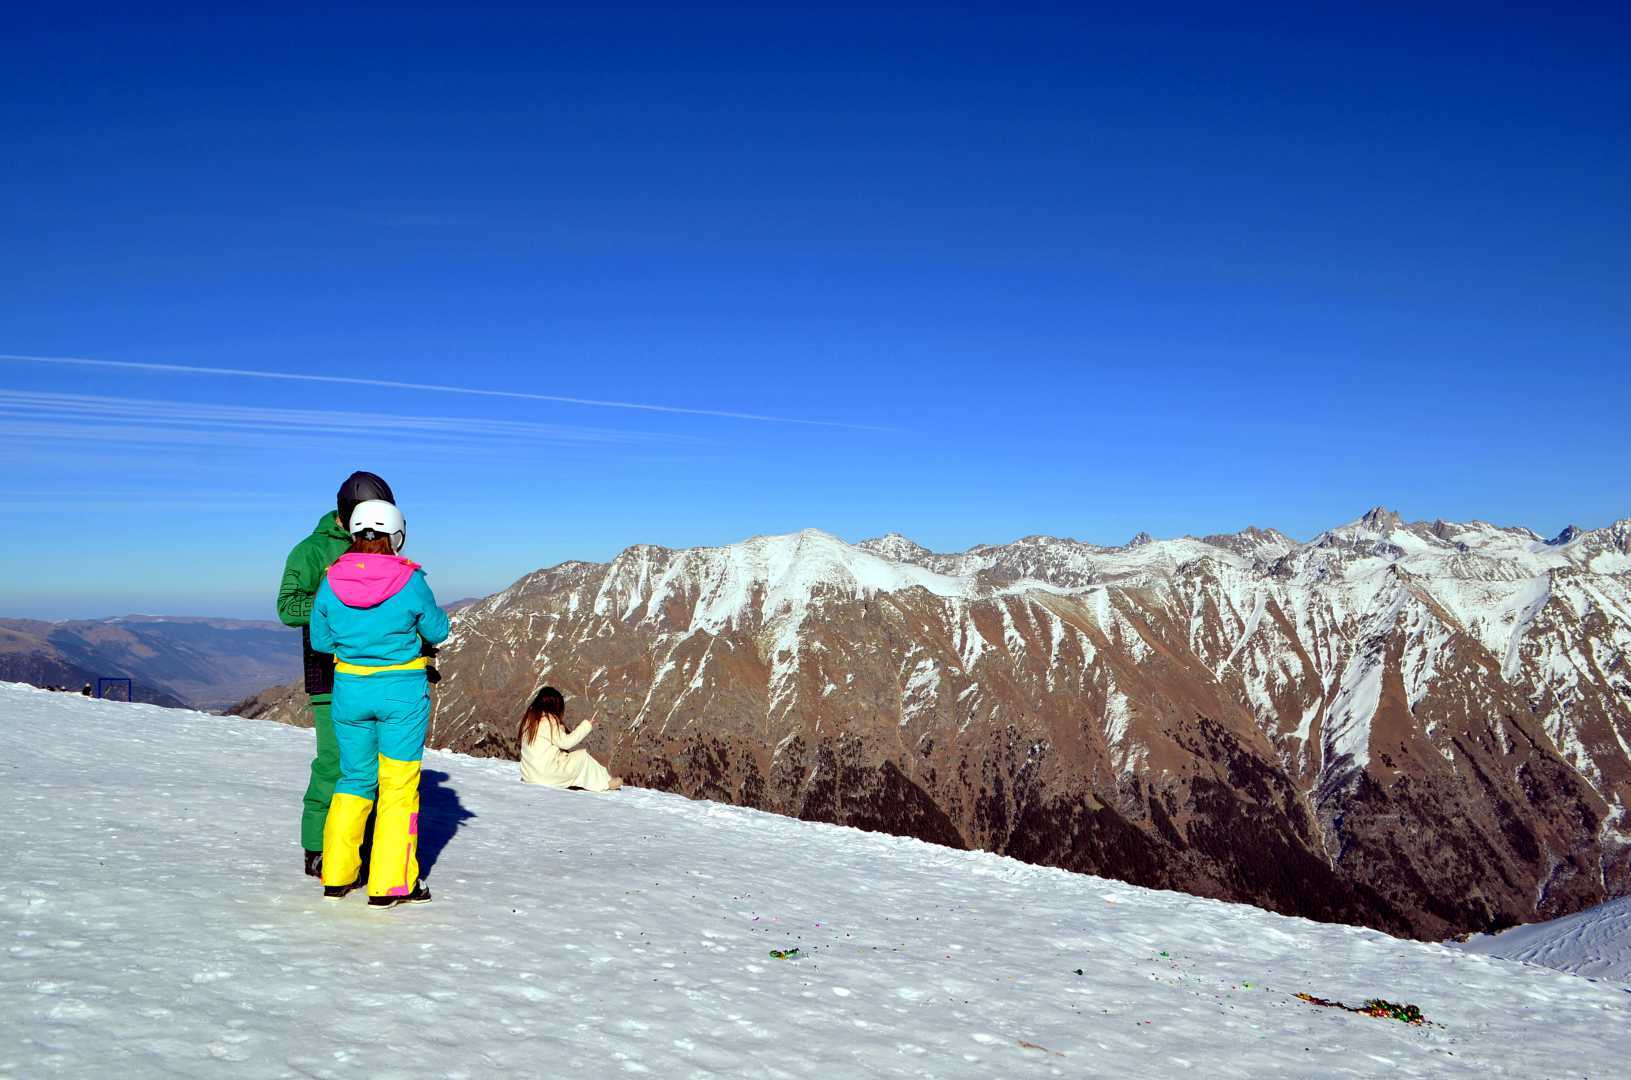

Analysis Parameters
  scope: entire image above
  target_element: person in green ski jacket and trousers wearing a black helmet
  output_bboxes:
[277,473,396,878]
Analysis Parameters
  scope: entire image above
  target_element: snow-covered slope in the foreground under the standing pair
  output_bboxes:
[0,684,1631,1078]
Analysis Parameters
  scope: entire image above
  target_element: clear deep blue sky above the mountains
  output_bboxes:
[0,5,1631,617]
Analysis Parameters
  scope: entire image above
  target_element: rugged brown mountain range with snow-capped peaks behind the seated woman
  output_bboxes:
[257,509,1631,936]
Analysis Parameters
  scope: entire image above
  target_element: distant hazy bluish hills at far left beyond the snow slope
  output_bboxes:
[0,615,300,710]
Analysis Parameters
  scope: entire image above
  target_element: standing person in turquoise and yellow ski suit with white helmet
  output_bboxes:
[312,499,447,907]
